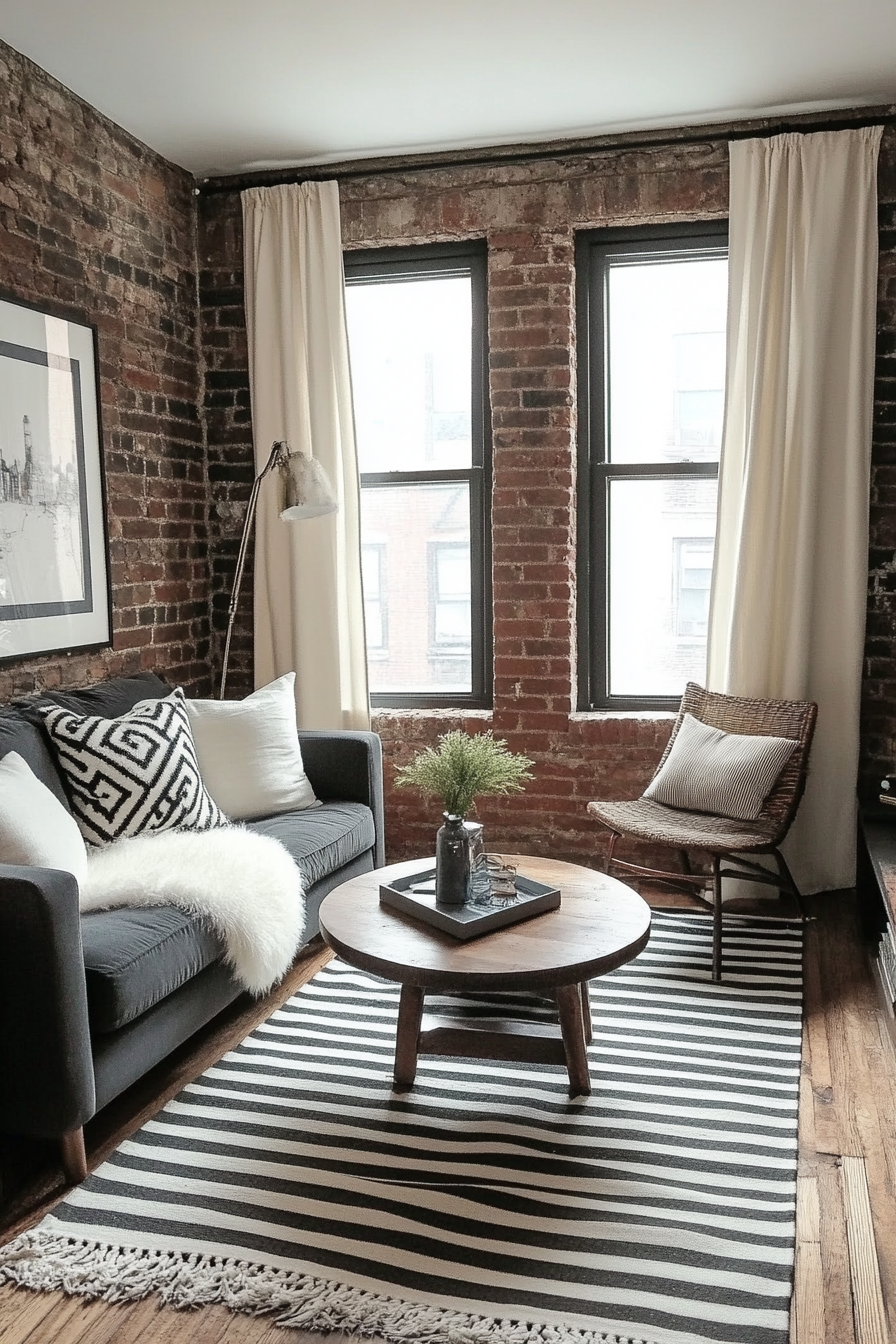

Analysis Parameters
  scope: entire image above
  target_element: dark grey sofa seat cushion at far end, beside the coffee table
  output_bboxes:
[246,802,376,891]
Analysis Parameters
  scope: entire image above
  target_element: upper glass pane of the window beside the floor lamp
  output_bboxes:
[345,276,473,472]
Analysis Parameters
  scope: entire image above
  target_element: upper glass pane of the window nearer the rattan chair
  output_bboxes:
[607,258,728,462]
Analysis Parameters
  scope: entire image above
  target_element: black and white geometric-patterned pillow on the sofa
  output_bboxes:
[40,688,227,845]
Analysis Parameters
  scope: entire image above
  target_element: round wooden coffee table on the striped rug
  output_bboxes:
[320,855,650,1097]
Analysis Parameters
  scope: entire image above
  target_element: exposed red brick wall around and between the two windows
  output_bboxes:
[199,128,896,863]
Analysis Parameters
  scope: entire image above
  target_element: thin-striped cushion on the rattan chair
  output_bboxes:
[643,714,798,821]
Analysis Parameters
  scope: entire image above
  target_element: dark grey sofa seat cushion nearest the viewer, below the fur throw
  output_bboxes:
[81,906,224,1035]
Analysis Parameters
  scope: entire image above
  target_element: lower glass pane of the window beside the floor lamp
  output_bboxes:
[361,482,473,694]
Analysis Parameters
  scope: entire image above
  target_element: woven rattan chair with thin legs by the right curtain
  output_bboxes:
[588,681,818,980]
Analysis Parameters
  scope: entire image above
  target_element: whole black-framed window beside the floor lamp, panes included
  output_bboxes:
[345,243,490,706]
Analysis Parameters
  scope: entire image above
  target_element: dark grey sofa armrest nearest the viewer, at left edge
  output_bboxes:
[0,864,97,1138]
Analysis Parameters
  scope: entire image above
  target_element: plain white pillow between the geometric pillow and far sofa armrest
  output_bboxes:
[187,672,317,821]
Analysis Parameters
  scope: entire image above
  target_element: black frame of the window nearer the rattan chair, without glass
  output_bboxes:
[575,219,728,712]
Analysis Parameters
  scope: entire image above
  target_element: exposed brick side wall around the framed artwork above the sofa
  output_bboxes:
[0,43,210,700]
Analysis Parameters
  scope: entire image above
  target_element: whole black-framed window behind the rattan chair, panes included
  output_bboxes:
[576,224,728,710]
